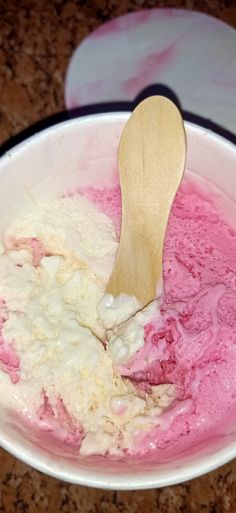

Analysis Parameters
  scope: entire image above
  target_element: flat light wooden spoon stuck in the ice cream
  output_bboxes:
[107,96,186,305]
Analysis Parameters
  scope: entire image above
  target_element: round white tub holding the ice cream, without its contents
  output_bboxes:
[0,113,236,490]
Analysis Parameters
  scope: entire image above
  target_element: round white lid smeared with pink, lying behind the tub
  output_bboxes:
[65,9,236,132]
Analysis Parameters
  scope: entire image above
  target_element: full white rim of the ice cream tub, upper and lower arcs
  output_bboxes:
[0,111,236,490]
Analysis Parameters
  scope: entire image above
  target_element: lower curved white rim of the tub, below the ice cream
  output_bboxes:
[0,422,236,490]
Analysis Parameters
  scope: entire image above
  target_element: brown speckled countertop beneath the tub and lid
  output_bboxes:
[0,0,236,513]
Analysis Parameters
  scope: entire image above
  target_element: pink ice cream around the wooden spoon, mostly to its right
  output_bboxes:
[80,180,236,459]
